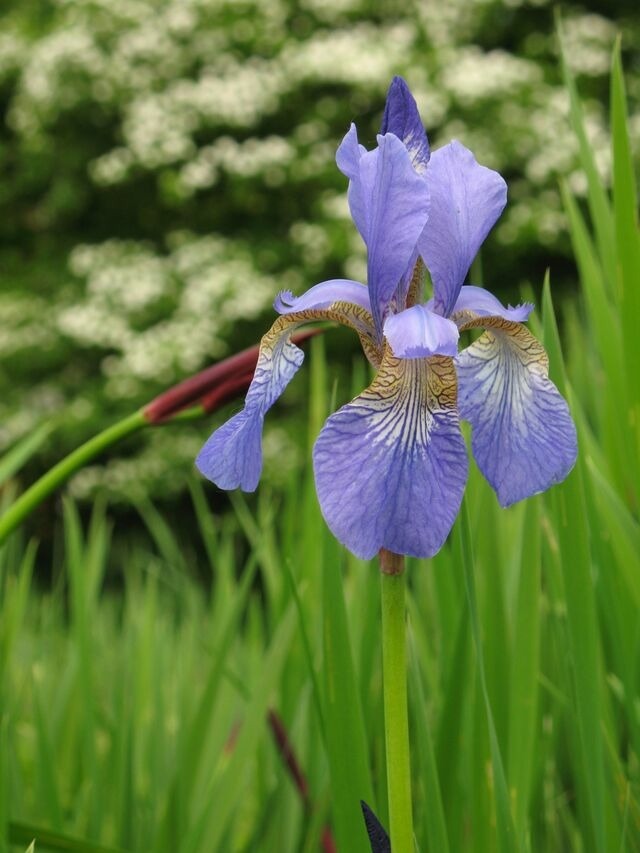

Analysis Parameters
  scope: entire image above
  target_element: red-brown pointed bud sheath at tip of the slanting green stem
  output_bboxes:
[143,329,323,424]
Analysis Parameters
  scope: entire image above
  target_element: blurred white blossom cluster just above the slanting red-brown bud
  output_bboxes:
[57,235,278,399]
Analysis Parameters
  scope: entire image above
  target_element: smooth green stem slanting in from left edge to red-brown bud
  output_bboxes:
[0,410,149,545]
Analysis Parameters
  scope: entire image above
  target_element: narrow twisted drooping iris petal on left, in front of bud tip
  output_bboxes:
[196,302,380,492]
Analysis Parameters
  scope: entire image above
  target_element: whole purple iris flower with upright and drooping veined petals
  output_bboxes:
[196,77,577,559]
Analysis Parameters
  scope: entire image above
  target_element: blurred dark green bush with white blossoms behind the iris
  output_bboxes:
[0,0,640,497]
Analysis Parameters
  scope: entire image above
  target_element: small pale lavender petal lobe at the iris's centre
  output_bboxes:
[384,305,459,358]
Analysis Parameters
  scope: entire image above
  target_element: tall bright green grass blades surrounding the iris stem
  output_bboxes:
[0,48,640,853]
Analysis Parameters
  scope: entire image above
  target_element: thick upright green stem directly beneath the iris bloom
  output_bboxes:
[380,548,413,853]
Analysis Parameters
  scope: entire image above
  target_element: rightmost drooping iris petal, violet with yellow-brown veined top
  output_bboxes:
[456,317,577,506]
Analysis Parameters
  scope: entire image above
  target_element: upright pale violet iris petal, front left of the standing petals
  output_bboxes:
[337,127,429,340]
